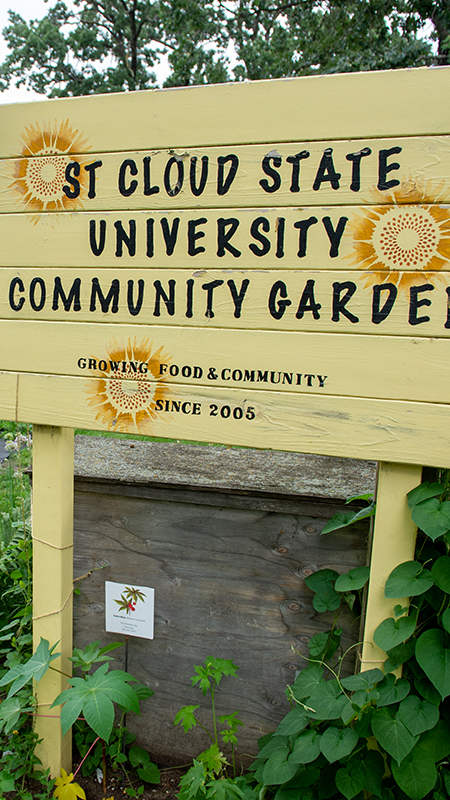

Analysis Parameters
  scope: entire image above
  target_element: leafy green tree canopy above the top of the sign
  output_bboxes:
[0,0,450,97]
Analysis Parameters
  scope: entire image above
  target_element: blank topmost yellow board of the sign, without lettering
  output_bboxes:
[0,67,450,158]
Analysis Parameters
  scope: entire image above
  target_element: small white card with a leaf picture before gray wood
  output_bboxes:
[105,581,155,639]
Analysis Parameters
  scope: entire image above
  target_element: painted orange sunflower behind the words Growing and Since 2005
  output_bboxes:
[86,337,170,435]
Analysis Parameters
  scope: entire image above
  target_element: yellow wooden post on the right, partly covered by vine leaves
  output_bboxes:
[361,462,422,671]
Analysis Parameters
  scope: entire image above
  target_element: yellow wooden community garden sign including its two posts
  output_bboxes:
[0,68,450,774]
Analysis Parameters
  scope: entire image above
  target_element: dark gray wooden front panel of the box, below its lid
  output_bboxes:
[74,486,366,763]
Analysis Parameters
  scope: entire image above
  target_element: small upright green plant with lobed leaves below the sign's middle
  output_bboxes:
[174,656,253,800]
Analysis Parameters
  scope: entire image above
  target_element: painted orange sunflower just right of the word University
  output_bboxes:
[348,178,450,289]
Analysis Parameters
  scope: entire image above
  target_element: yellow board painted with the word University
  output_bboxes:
[0,205,450,274]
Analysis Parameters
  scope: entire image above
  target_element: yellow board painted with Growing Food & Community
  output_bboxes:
[0,320,450,403]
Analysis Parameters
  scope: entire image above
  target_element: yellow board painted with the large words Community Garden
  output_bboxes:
[0,268,450,338]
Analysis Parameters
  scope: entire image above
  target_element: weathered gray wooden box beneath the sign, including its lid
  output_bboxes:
[74,437,374,763]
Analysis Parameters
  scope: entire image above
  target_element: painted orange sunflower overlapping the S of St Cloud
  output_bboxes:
[9,120,88,216]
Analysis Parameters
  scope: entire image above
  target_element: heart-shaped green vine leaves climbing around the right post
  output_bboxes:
[244,476,450,800]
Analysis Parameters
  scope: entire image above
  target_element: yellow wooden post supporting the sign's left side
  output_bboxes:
[33,425,73,777]
